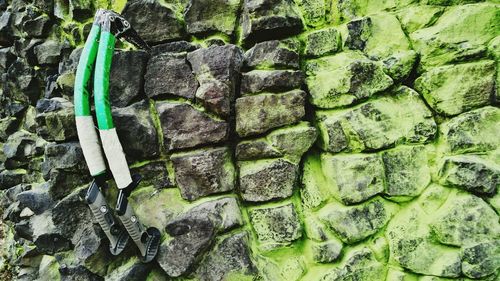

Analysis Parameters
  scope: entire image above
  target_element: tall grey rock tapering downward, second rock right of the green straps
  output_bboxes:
[187,45,243,117]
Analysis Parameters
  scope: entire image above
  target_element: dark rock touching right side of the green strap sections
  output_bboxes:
[109,51,148,107]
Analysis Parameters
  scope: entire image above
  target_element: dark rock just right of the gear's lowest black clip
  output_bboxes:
[157,215,215,277]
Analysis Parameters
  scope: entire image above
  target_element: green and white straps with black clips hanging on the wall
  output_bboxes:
[74,9,160,262]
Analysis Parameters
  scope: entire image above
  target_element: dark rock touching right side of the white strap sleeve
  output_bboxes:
[112,101,160,162]
